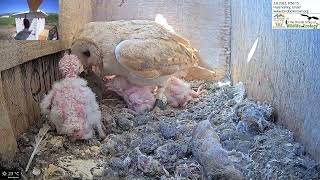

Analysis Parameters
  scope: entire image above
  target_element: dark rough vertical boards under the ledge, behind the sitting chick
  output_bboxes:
[1,52,63,135]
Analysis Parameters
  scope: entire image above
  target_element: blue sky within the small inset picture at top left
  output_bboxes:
[0,0,59,14]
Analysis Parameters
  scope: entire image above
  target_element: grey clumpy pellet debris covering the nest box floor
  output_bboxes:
[1,82,320,179]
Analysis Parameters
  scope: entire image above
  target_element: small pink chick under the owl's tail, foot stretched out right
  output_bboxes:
[164,77,206,107]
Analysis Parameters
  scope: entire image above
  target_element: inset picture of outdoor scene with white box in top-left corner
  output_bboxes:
[0,0,59,40]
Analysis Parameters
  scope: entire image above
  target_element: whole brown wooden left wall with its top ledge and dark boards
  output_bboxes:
[0,41,65,159]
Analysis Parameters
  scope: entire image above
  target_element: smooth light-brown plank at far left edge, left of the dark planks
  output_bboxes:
[0,73,17,160]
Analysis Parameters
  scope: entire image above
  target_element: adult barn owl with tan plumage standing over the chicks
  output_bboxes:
[71,20,201,107]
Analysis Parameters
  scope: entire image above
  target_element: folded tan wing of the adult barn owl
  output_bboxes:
[115,38,200,79]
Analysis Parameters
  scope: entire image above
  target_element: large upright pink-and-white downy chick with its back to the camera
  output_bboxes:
[40,55,105,139]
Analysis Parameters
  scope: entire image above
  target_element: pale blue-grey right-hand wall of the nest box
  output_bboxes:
[231,0,320,161]
